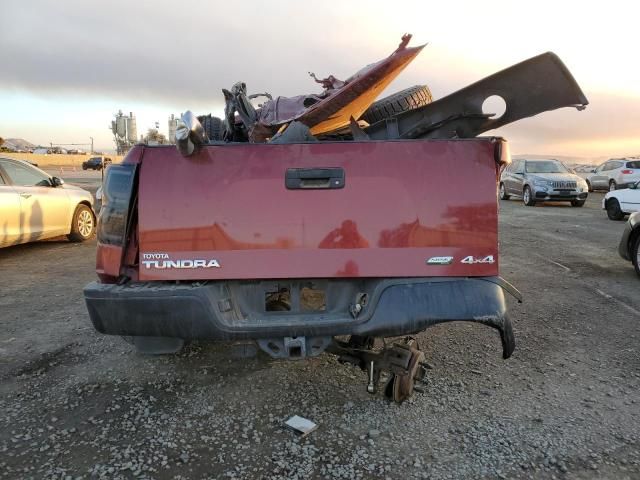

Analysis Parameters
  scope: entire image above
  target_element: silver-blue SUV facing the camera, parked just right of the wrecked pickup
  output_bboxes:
[498,159,588,207]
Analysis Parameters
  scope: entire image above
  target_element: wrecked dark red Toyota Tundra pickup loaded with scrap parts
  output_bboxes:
[84,35,588,402]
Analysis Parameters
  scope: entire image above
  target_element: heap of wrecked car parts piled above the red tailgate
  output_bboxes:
[177,35,588,149]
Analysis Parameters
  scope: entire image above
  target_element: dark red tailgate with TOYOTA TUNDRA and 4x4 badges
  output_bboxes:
[138,138,502,280]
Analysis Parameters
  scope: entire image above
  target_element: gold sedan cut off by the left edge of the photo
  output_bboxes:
[0,157,96,247]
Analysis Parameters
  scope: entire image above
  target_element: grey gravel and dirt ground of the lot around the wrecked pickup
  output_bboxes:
[0,189,640,479]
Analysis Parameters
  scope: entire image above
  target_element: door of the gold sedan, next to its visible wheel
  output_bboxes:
[0,159,73,241]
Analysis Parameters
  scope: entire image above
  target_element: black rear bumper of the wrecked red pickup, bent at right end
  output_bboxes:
[84,277,515,358]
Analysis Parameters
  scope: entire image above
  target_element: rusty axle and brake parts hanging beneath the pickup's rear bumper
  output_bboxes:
[327,336,431,403]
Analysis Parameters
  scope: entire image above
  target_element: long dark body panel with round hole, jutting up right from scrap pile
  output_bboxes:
[365,52,589,140]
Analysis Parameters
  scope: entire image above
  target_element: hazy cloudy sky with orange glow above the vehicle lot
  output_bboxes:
[0,0,640,159]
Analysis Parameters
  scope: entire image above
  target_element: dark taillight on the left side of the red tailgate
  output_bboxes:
[98,164,137,246]
